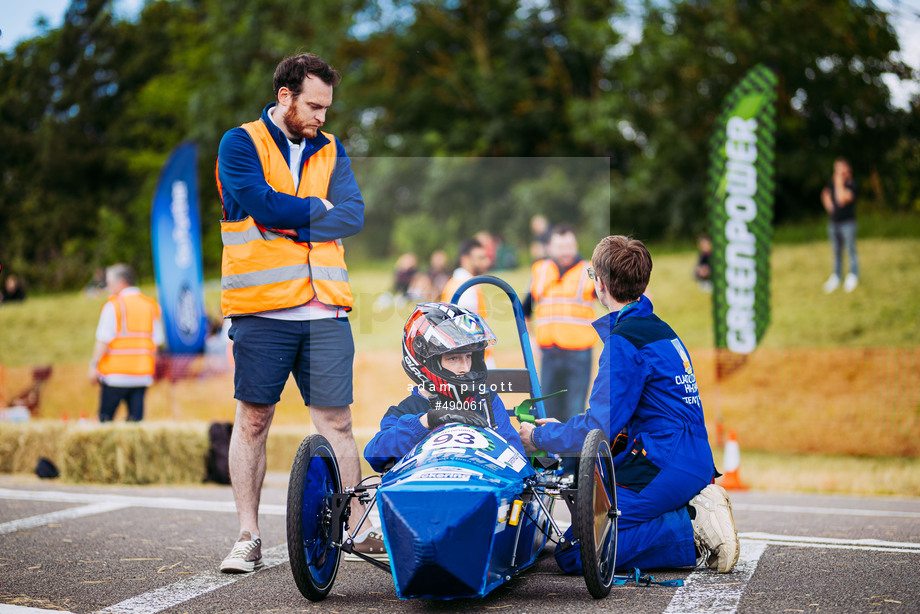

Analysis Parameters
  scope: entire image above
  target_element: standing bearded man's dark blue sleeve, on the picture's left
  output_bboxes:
[217,128,328,229]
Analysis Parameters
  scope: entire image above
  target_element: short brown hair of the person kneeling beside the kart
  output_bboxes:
[591,235,652,304]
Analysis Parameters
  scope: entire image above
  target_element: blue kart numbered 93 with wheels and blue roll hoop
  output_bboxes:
[287,276,619,601]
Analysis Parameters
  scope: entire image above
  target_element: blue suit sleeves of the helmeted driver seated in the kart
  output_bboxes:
[364,388,527,471]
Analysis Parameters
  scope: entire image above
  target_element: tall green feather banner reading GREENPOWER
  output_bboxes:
[707,65,776,358]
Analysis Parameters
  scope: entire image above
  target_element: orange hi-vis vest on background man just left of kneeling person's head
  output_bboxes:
[530,259,597,350]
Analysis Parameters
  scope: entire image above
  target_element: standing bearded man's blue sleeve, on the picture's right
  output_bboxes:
[297,138,364,242]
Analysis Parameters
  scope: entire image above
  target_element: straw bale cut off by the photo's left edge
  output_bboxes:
[0,421,67,473]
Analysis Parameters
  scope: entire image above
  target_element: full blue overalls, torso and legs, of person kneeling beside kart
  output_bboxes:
[533,296,715,571]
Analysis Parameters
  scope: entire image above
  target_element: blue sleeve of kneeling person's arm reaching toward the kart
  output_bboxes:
[533,335,646,453]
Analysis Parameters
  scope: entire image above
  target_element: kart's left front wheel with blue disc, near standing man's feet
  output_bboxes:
[287,435,342,601]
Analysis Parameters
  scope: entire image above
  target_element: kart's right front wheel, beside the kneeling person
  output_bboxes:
[573,429,619,599]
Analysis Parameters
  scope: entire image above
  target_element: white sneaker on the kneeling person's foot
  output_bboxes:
[690,484,741,573]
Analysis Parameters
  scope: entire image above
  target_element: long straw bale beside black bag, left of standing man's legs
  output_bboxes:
[61,422,208,484]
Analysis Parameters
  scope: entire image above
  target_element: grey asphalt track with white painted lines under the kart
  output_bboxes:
[0,474,920,614]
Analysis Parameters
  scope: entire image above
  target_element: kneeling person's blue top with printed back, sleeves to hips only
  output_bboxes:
[533,296,714,490]
